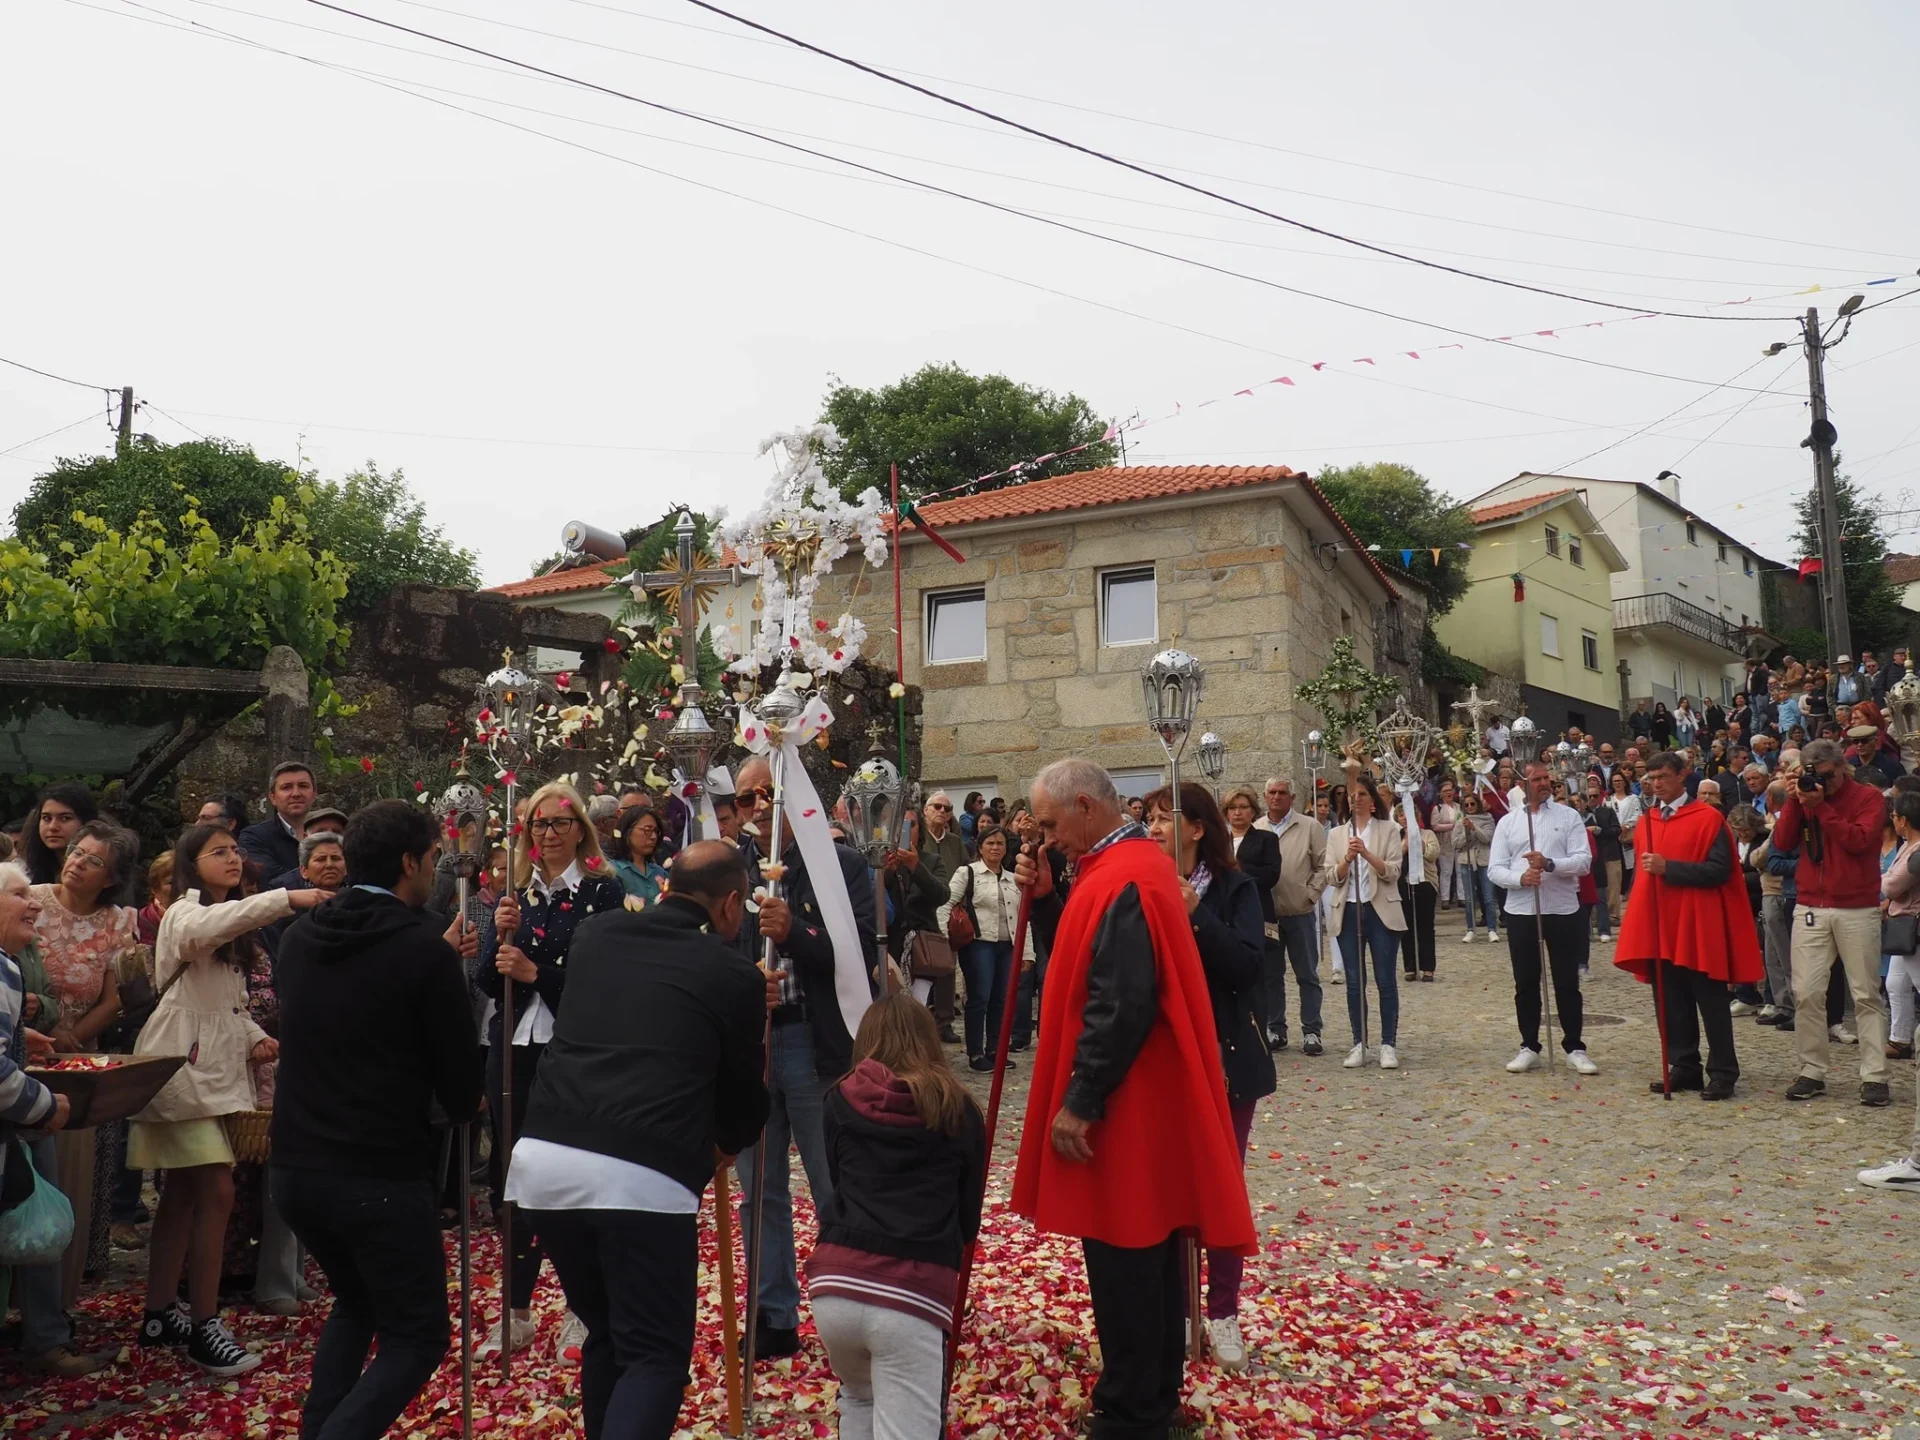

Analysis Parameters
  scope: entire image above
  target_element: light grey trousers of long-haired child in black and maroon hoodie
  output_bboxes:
[812,1294,947,1440]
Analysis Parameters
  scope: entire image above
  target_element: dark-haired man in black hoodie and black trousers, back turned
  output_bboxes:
[267,801,480,1440]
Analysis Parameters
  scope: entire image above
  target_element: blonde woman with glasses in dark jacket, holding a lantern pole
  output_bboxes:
[480,783,626,1361]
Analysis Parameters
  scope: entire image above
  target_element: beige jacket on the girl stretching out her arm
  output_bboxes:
[132,891,294,1123]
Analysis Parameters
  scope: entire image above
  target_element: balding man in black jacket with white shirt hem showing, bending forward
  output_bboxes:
[507,841,768,1440]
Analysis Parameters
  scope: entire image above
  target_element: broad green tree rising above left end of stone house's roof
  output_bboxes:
[820,365,1119,499]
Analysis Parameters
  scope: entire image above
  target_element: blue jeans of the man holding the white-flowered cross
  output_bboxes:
[739,1029,833,1331]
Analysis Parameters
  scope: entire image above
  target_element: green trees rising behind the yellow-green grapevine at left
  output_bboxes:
[13,440,480,612]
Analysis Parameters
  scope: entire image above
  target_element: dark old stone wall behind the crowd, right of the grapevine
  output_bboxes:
[177,586,612,818]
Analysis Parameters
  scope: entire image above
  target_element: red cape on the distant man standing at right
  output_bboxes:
[1613,801,1766,985]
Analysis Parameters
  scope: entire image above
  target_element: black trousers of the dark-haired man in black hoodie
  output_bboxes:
[267,1165,451,1440]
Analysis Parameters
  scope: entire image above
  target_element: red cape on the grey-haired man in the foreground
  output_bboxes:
[1014,837,1254,1254]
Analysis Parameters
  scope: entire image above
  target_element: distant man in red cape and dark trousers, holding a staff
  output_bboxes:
[1613,751,1764,1100]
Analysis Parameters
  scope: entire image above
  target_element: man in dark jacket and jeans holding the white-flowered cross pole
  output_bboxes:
[737,756,876,1357]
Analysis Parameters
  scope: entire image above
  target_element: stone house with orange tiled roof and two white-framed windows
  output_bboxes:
[816,465,1425,799]
